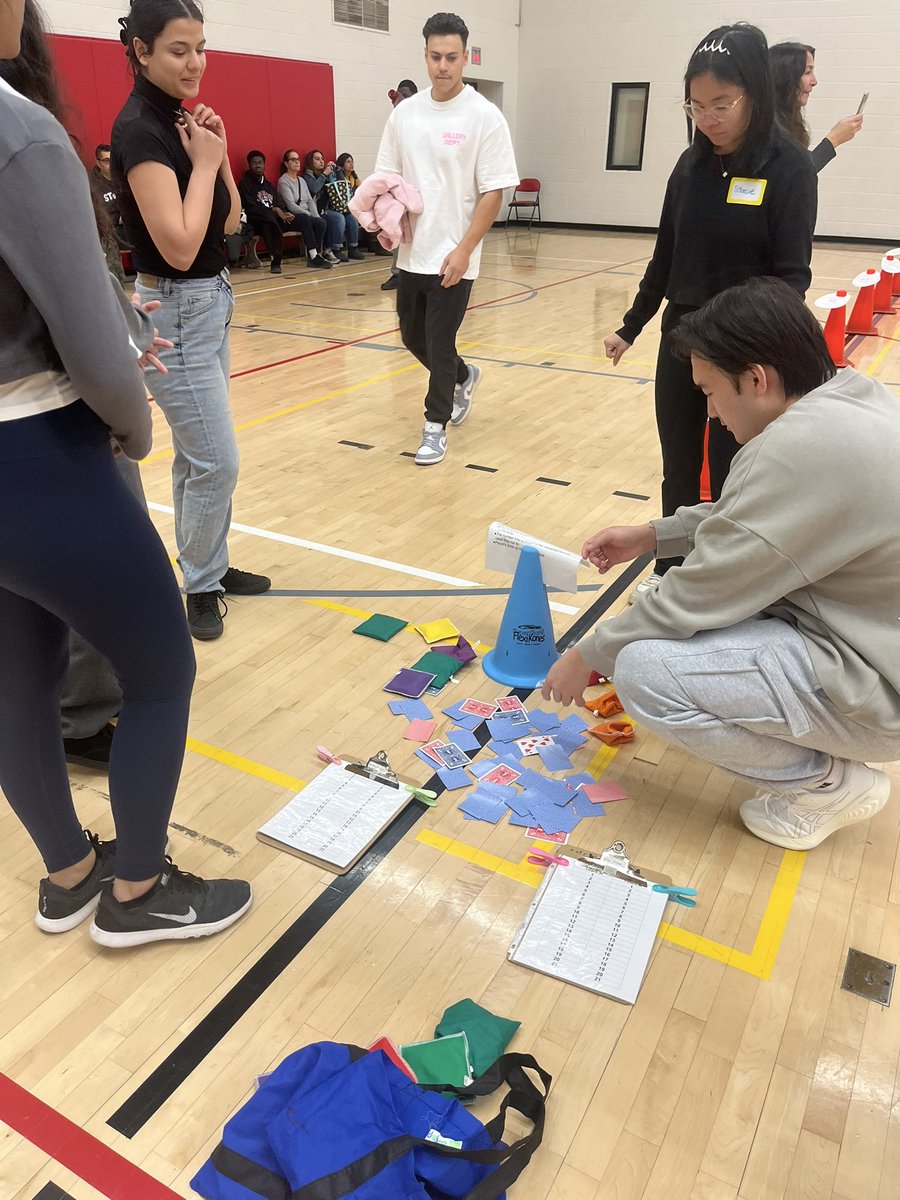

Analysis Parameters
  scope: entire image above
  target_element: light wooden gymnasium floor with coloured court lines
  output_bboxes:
[0,230,900,1200]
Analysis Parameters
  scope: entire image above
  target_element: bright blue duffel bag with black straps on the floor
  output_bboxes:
[191,1042,551,1200]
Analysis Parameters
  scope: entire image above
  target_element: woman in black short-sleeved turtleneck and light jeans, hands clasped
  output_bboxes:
[112,0,271,641]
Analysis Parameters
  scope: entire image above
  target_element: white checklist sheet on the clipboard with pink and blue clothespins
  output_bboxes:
[509,859,667,1004]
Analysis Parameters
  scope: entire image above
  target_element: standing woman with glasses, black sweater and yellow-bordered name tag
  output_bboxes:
[604,23,816,600]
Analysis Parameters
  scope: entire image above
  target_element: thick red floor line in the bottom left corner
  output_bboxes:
[0,1074,184,1200]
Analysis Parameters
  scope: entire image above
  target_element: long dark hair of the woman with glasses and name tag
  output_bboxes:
[684,22,775,175]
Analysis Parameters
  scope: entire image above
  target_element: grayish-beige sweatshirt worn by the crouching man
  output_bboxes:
[578,368,900,733]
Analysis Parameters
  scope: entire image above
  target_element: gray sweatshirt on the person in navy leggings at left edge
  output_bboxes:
[0,80,152,458]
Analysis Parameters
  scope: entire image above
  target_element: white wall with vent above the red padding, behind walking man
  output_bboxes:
[42,0,518,174]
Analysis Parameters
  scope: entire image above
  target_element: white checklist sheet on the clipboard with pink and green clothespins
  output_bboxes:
[257,763,410,874]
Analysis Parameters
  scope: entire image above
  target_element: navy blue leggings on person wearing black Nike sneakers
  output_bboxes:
[0,401,194,881]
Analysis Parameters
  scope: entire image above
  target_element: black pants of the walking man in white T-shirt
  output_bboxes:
[397,271,473,426]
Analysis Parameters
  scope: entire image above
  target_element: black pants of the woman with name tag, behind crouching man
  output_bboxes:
[655,305,740,575]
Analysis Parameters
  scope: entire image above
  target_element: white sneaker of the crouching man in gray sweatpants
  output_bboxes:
[740,758,890,850]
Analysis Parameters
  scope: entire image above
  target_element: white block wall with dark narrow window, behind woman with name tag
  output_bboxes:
[516,0,900,246]
